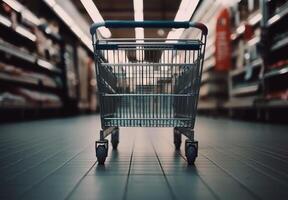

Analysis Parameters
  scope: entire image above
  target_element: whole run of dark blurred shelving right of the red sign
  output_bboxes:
[225,0,288,120]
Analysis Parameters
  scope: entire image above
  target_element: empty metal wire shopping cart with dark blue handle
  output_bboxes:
[90,21,208,164]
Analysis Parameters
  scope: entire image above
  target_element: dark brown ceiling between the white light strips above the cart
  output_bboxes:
[72,0,181,38]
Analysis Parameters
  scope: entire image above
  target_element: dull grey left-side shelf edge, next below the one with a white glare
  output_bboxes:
[0,73,61,93]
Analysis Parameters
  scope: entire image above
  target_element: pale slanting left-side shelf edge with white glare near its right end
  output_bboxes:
[0,43,61,74]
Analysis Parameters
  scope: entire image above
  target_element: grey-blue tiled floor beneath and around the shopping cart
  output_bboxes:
[0,116,288,200]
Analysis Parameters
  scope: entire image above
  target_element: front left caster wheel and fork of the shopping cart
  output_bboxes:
[95,130,108,165]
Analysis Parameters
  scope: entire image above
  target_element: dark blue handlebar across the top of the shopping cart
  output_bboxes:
[90,20,208,35]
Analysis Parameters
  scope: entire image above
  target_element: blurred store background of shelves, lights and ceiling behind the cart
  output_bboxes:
[0,0,288,121]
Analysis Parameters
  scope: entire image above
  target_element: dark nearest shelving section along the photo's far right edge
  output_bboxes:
[258,0,288,118]
